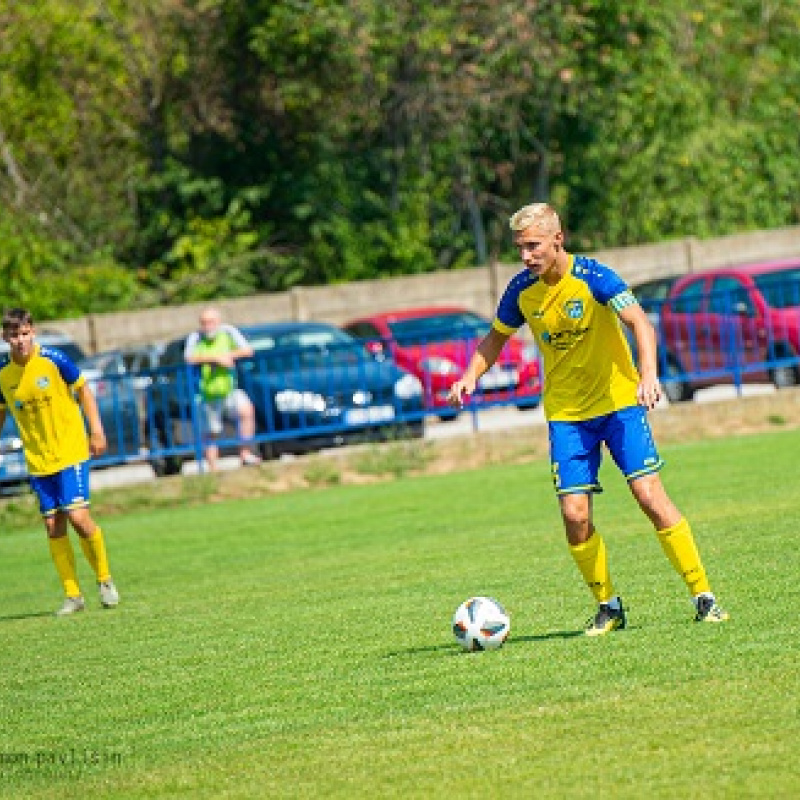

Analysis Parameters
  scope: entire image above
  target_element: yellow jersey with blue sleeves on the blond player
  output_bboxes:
[493,255,639,422]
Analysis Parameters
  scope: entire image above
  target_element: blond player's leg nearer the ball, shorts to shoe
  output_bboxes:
[549,422,626,636]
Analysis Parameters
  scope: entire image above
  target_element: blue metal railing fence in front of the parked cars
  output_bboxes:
[0,281,800,490]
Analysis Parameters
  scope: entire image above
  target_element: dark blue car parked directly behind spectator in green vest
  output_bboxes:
[145,322,424,475]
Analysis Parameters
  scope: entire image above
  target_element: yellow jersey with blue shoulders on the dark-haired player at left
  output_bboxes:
[0,344,89,475]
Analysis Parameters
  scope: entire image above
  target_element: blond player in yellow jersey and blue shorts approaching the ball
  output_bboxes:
[449,203,728,636]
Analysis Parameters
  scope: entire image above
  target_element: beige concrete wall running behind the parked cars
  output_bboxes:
[50,226,800,352]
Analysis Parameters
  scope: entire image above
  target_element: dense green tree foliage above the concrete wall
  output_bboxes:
[0,0,800,318]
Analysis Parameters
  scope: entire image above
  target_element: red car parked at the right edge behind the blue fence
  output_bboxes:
[660,259,800,401]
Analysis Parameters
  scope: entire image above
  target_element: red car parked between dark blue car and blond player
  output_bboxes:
[342,306,542,418]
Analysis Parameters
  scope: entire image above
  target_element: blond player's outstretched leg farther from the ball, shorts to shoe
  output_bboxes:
[606,407,728,622]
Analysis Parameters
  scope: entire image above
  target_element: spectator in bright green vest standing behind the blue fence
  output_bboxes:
[183,307,261,472]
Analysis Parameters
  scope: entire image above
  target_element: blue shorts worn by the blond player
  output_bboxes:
[548,406,664,495]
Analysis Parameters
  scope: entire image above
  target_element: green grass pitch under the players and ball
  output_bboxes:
[0,432,800,800]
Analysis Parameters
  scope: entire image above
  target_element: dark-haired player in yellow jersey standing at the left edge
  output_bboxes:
[0,308,119,616]
